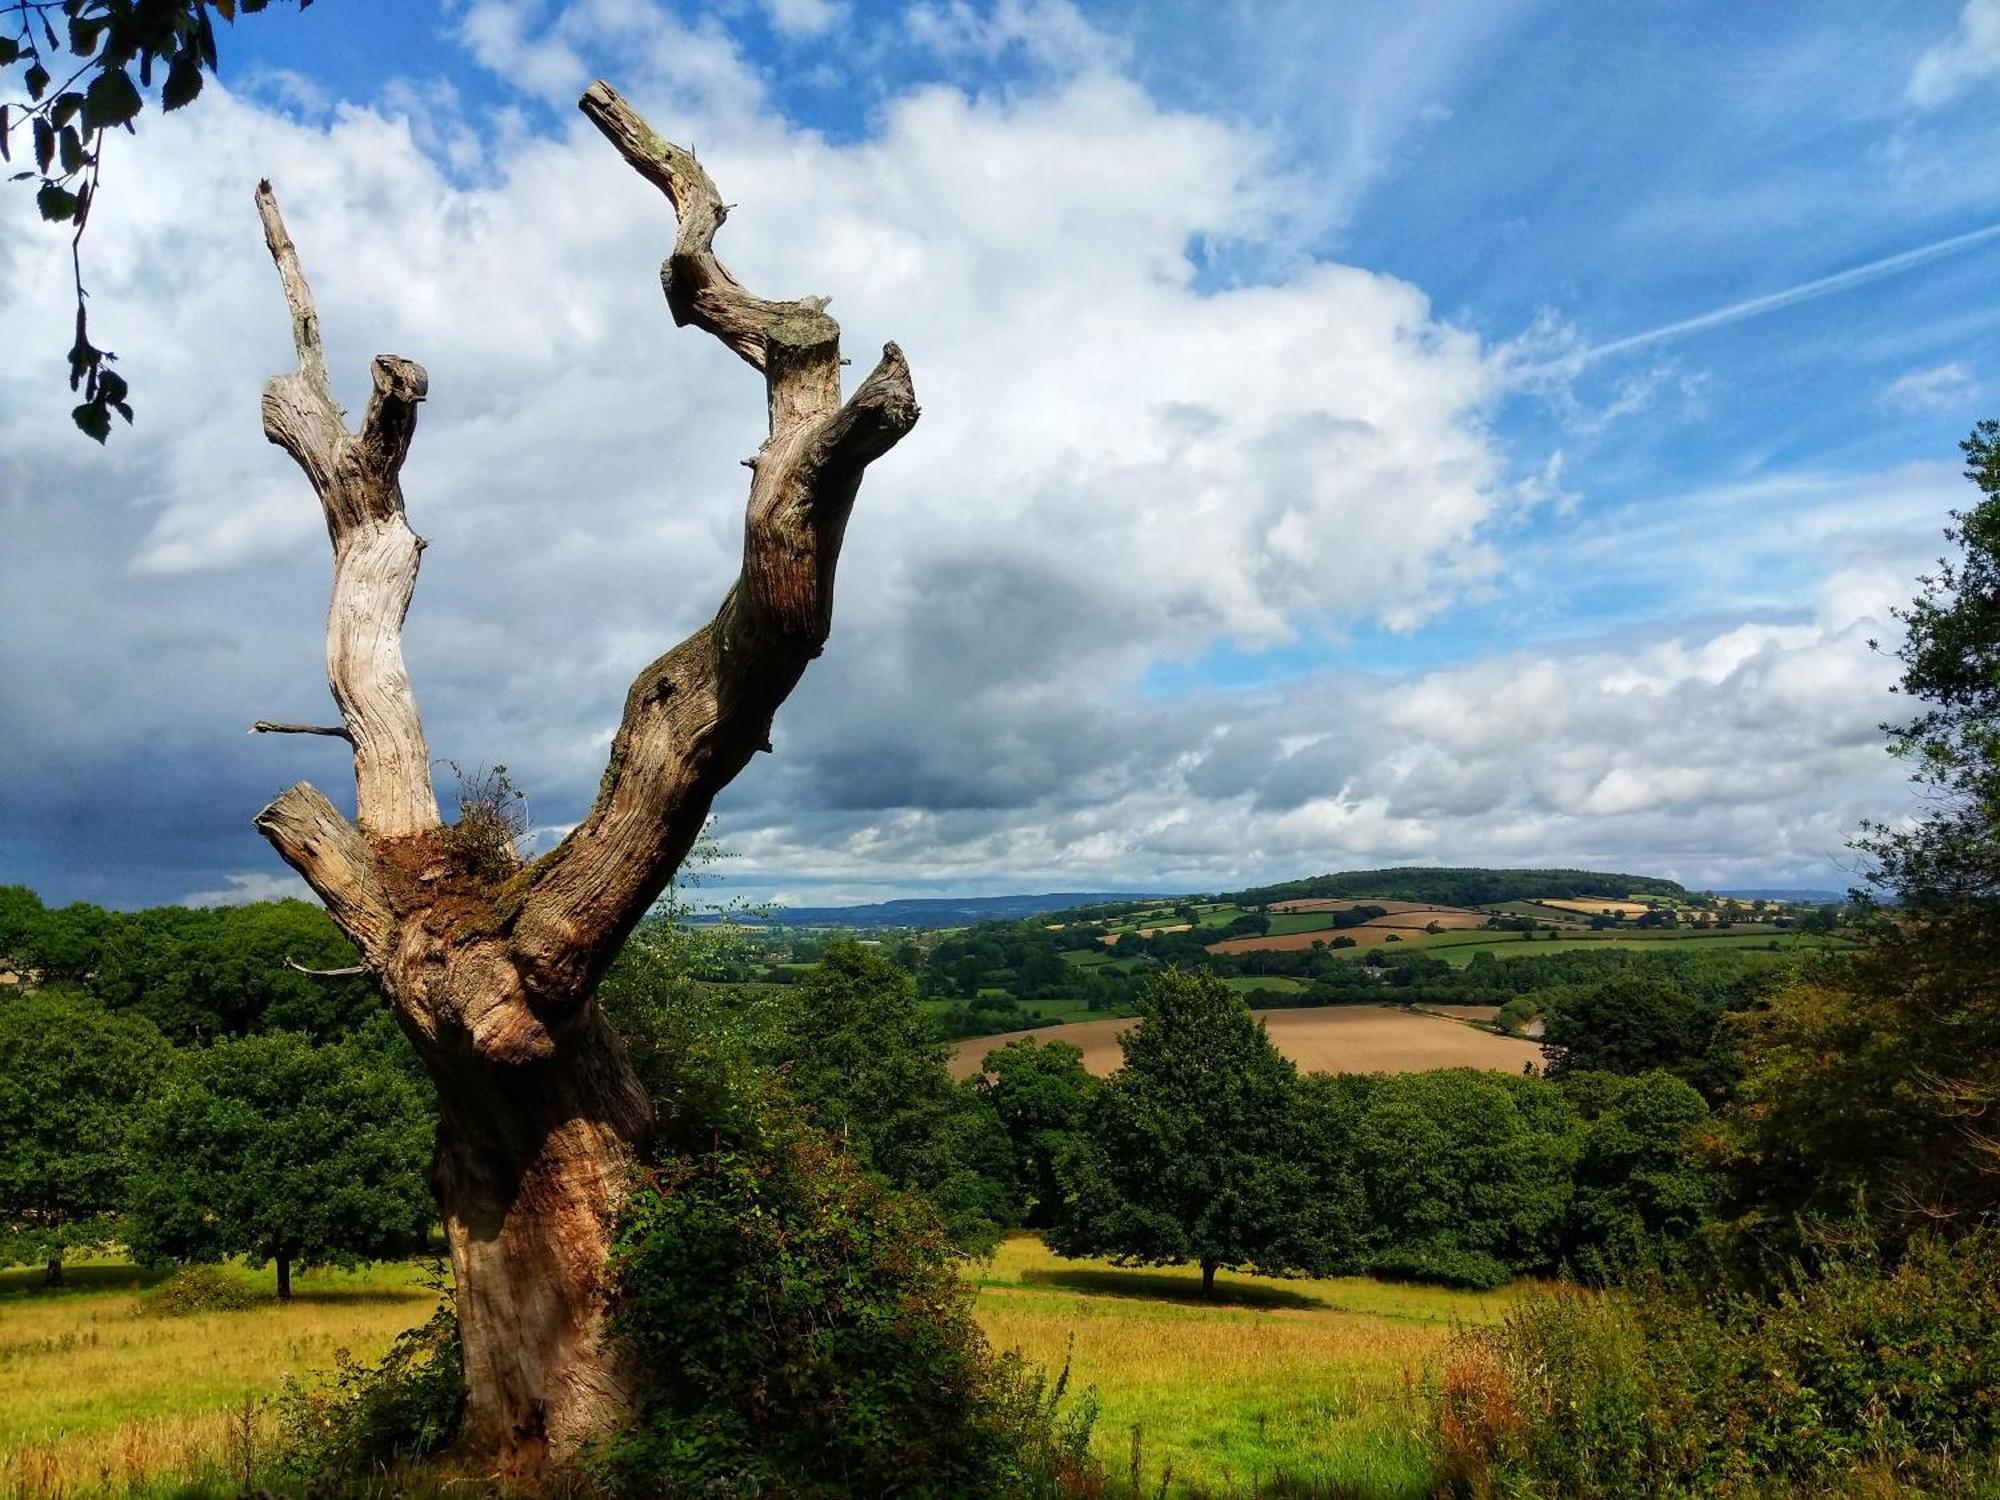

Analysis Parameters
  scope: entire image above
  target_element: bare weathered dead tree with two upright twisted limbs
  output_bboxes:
[256,82,918,1474]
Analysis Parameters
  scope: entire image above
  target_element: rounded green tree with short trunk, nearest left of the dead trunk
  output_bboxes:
[132,1032,432,1300]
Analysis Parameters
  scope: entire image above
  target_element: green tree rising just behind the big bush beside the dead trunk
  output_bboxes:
[766,942,1018,1248]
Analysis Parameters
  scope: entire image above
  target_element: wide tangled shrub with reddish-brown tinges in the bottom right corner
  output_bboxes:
[1436,1230,2000,1500]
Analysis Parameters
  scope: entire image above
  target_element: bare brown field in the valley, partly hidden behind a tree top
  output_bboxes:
[952,1006,1542,1078]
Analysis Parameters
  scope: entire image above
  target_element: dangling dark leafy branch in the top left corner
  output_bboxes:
[0,0,312,442]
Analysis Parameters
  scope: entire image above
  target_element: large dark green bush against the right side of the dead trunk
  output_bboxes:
[594,1102,1094,1500]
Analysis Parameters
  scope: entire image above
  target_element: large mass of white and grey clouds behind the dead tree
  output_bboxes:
[0,0,1950,900]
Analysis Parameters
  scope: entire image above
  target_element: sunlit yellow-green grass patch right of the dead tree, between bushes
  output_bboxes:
[976,1240,1508,1500]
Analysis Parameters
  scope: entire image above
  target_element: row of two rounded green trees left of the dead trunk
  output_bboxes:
[0,986,436,1298]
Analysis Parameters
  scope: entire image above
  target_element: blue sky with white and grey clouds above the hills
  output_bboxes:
[0,0,2000,906]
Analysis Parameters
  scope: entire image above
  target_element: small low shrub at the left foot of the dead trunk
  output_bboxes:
[278,1304,466,1494]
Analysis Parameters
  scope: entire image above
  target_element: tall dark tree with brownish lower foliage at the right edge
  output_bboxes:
[1720,422,2000,1250]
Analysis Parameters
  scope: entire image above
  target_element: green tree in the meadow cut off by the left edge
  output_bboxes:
[0,988,172,1284]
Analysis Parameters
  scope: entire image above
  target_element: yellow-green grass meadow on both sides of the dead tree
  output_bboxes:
[0,1236,1506,1500]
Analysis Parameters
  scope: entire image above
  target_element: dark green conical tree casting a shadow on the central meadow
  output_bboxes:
[1048,972,1308,1296]
